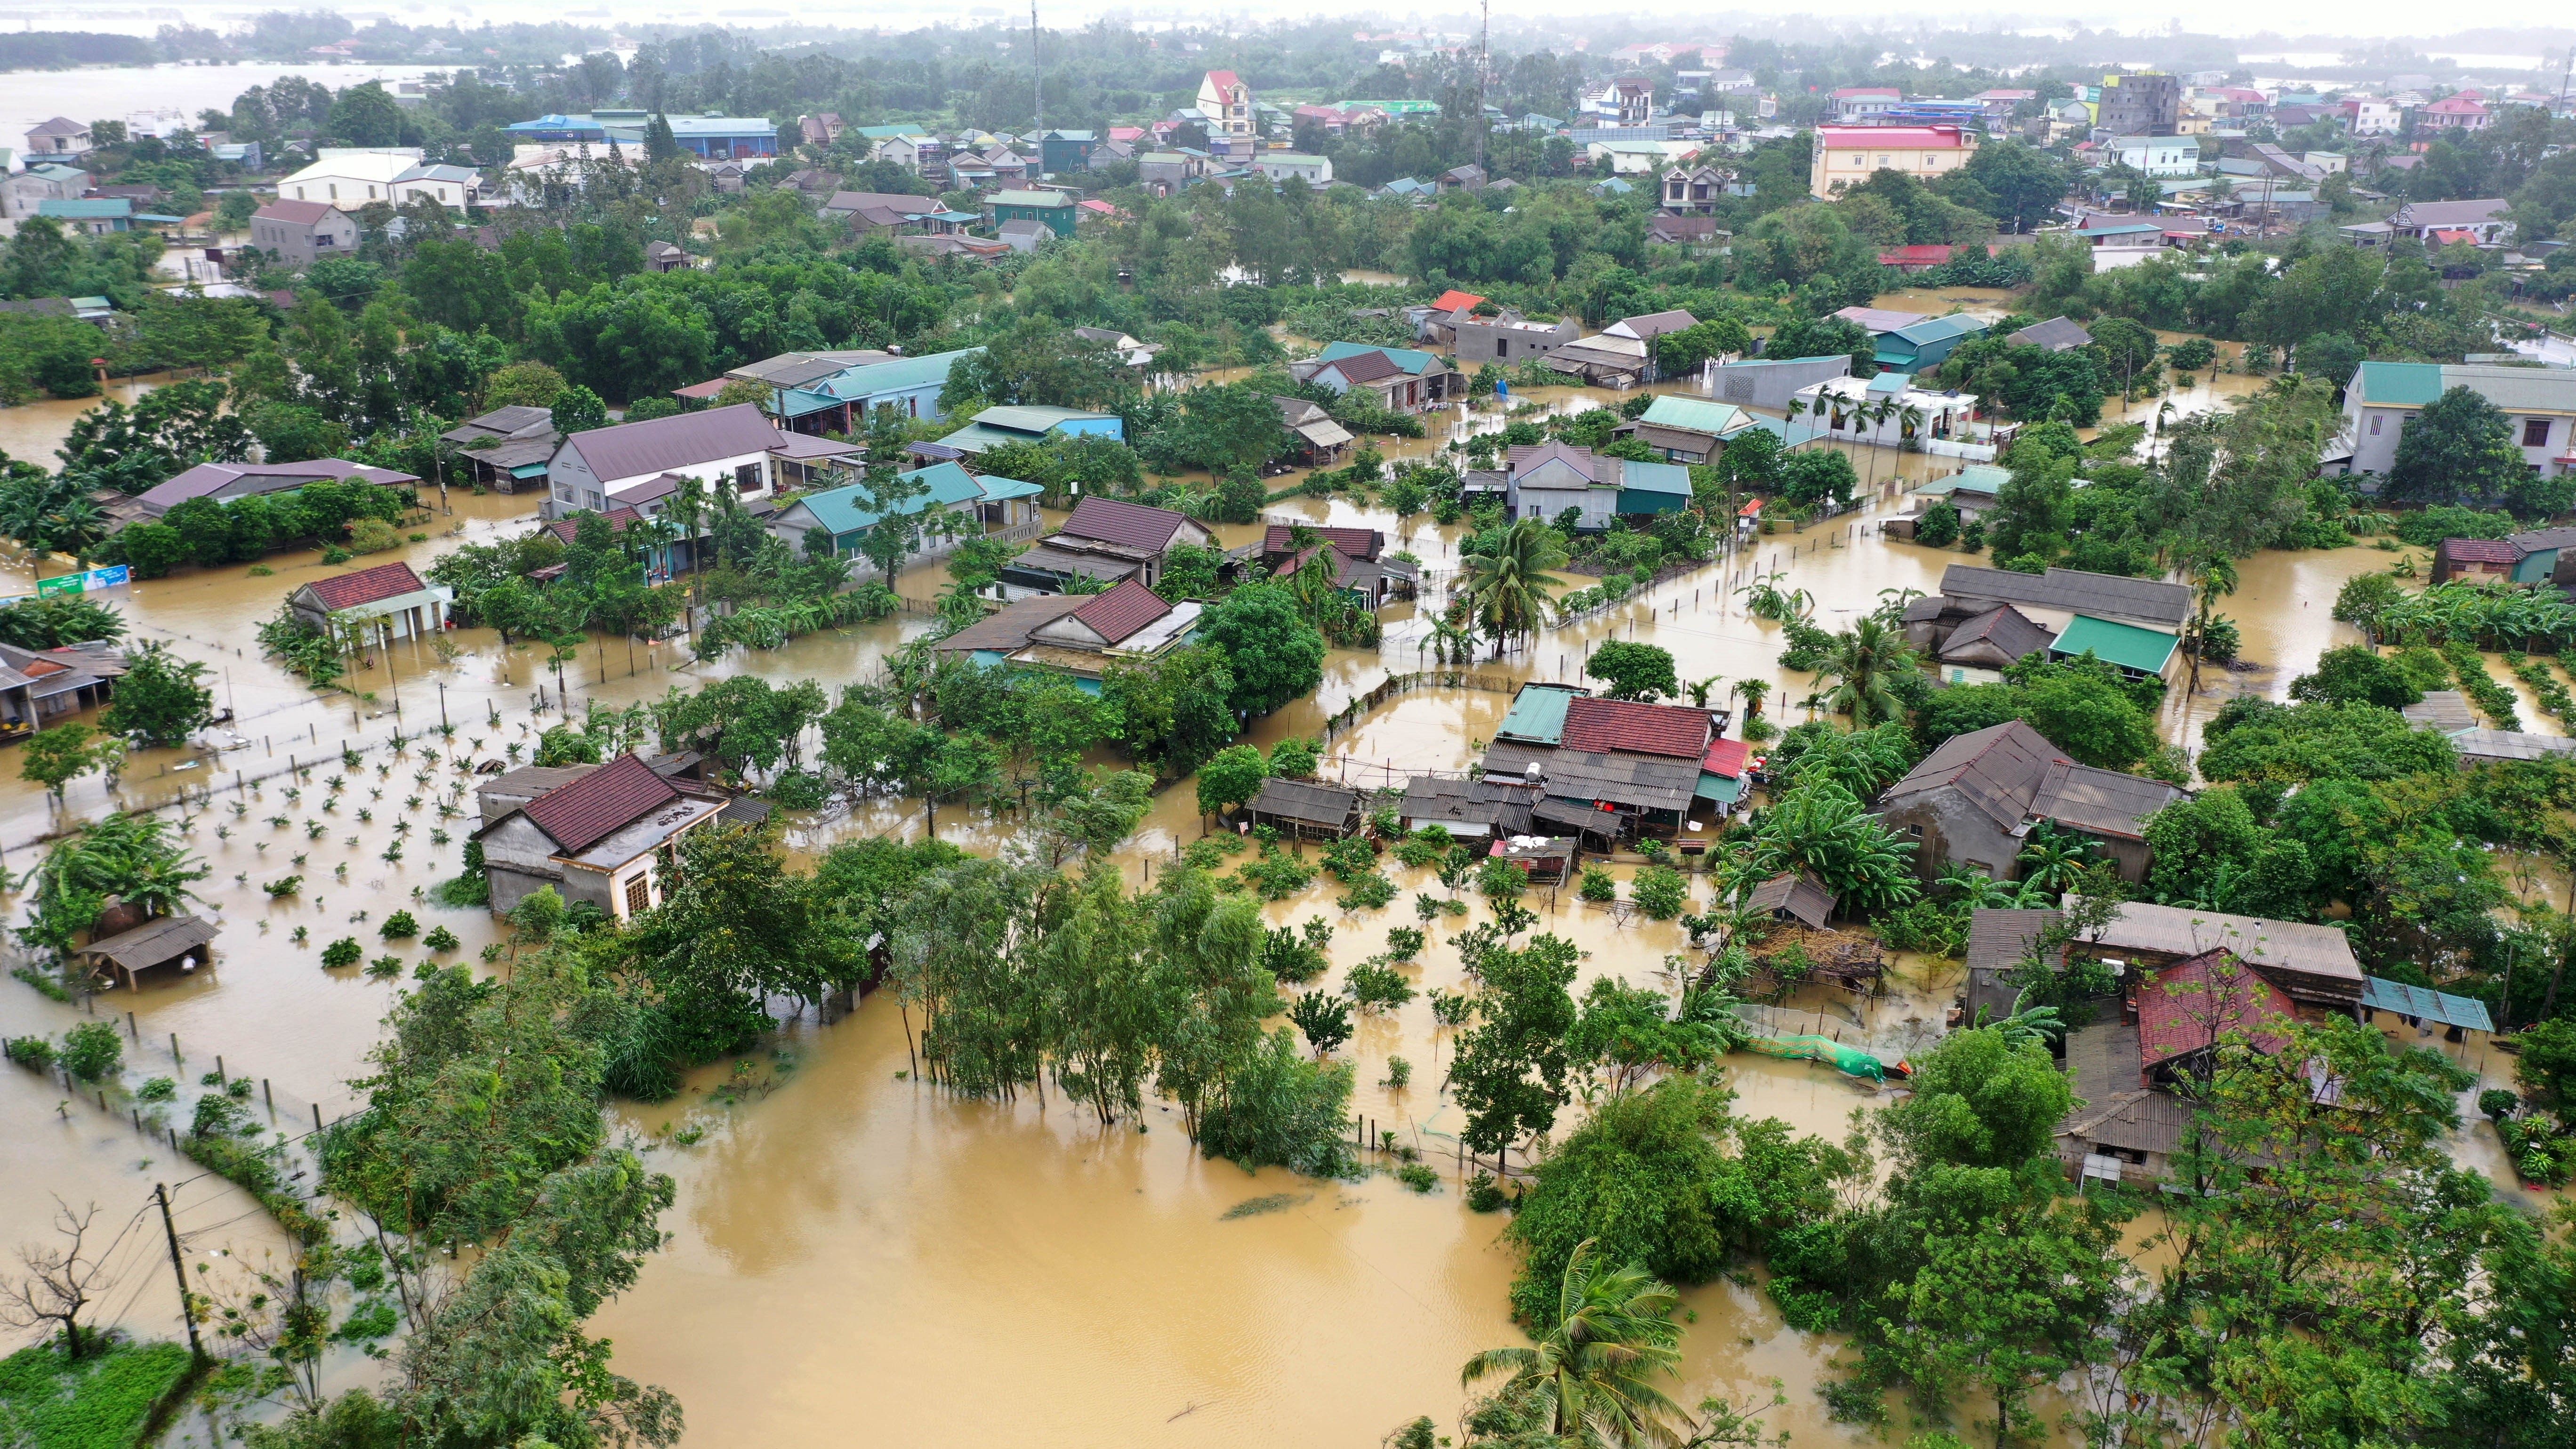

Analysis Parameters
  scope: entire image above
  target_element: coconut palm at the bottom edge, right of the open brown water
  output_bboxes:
[1458,1238,1685,1449]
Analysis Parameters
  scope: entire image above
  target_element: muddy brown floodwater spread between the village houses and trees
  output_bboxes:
[0,366,2555,1449]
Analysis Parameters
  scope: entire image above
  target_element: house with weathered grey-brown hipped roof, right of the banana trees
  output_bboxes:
[1876,719,2184,882]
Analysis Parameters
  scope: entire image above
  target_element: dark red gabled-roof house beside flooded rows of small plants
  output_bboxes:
[474,753,726,920]
